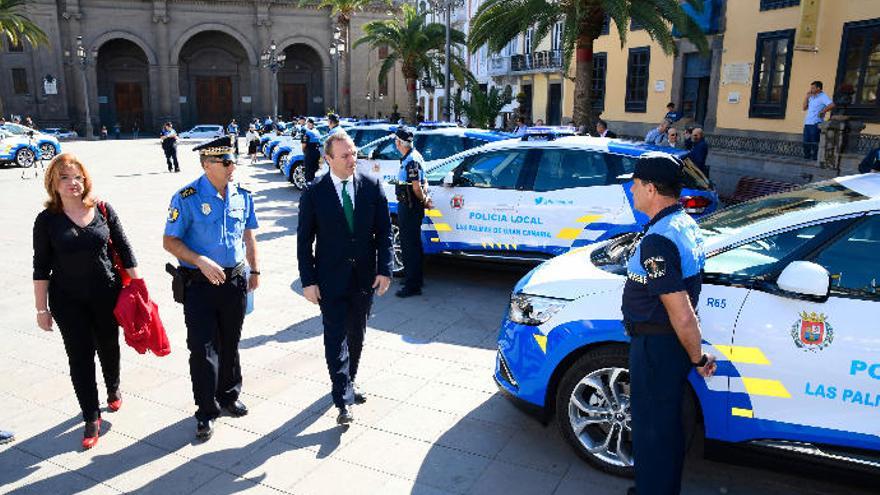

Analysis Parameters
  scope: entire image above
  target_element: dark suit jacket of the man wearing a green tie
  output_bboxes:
[296,172,393,298]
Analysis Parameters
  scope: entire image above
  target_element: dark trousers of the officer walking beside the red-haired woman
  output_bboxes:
[183,274,247,420]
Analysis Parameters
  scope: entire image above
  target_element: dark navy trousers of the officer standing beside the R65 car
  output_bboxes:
[629,329,693,495]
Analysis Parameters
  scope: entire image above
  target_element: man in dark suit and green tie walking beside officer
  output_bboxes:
[297,132,393,424]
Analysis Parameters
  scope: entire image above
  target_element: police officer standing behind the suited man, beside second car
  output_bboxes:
[394,127,433,297]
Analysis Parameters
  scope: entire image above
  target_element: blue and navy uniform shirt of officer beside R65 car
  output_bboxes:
[622,205,706,329]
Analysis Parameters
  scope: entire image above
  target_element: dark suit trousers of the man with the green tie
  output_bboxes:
[320,284,373,407]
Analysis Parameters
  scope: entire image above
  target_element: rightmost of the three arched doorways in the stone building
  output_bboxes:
[278,43,326,119]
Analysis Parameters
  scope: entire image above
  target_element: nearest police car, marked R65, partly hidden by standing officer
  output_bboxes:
[494,174,880,475]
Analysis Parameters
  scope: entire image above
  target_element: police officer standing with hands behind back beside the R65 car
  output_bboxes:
[622,153,715,495]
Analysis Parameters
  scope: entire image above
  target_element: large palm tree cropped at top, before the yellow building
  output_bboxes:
[468,0,709,129]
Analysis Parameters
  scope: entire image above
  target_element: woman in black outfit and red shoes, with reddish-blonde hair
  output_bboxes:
[34,153,139,449]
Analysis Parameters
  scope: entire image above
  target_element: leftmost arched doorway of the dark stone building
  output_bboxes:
[96,38,152,133]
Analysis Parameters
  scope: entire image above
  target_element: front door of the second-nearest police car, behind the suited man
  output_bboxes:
[434,148,535,251]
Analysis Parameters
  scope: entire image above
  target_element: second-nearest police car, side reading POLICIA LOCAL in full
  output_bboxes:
[386,129,718,271]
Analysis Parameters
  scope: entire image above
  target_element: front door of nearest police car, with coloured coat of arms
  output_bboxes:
[707,216,880,448]
